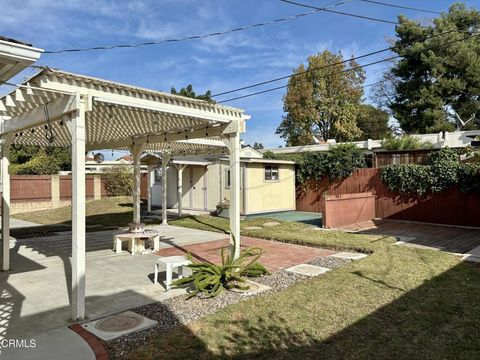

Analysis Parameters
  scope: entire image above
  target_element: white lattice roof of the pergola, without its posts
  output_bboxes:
[0,68,248,154]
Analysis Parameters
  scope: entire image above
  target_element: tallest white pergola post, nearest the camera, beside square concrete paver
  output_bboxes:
[70,95,87,320]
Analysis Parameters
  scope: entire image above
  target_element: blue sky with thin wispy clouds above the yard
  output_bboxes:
[0,0,480,154]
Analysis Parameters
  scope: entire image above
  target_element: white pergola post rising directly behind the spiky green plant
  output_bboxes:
[224,121,243,258]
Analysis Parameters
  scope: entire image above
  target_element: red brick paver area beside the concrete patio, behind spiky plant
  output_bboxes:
[158,237,336,271]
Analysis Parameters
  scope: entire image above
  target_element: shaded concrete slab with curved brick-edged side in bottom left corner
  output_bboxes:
[0,326,95,360]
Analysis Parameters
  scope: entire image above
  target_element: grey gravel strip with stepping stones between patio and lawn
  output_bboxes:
[106,258,344,359]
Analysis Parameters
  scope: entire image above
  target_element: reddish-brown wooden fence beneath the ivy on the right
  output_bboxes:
[297,169,480,227]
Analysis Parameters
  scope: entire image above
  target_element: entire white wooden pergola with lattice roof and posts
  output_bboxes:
[0,68,249,320]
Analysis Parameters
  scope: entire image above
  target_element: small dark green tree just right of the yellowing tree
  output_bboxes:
[357,104,392,140]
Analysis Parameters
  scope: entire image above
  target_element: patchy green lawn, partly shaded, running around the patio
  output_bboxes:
[13,199,480,359]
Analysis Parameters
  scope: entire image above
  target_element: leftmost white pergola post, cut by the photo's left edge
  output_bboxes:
[1,136,11,271]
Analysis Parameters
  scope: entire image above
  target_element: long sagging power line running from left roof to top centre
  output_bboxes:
[44,0,353,54]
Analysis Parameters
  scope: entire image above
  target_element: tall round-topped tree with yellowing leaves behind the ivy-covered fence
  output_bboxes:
[276,51,365,146]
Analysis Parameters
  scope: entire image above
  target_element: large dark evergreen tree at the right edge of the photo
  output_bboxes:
[389,4,480,133]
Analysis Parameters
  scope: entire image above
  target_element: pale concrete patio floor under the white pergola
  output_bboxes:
[0,226,225,338]
